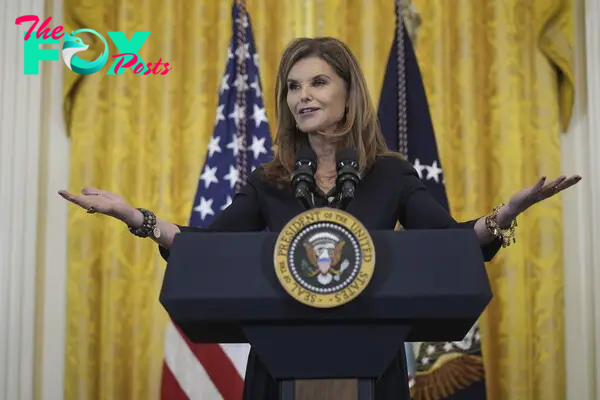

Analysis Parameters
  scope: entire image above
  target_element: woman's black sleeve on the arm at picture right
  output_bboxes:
[398,166,502,262]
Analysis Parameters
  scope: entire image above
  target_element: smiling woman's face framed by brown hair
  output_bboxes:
[287,57,347,133]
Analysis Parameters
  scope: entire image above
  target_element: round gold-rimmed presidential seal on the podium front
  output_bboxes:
[273,208,375,308]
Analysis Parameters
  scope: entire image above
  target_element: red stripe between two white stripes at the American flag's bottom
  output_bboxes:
[175,325,244,400]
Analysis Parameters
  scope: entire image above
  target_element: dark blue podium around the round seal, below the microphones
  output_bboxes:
[160,229,492,400]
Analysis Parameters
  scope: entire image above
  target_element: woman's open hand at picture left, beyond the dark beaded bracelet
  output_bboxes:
[58,187,144,228]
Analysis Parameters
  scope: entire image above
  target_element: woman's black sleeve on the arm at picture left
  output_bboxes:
[158,170,266,261]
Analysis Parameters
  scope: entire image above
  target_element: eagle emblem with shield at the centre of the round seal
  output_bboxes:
[303,240,349,285]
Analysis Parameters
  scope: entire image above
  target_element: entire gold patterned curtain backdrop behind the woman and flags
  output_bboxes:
[64,0,572,400]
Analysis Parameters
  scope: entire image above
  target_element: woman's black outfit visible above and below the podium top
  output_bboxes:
[159,156,501,400]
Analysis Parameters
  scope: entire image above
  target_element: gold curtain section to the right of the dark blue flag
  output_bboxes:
[413,0,573,400]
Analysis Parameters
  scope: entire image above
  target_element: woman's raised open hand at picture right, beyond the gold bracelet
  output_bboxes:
[506,175,581,216]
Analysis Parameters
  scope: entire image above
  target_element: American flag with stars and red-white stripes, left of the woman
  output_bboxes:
[162,1,272,400]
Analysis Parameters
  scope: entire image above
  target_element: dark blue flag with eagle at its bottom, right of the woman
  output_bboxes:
[379,1,486,400]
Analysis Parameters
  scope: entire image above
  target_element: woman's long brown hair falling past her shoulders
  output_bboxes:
[264,37,399,185]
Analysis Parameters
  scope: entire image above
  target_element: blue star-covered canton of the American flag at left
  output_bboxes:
[190,2,272,227]
